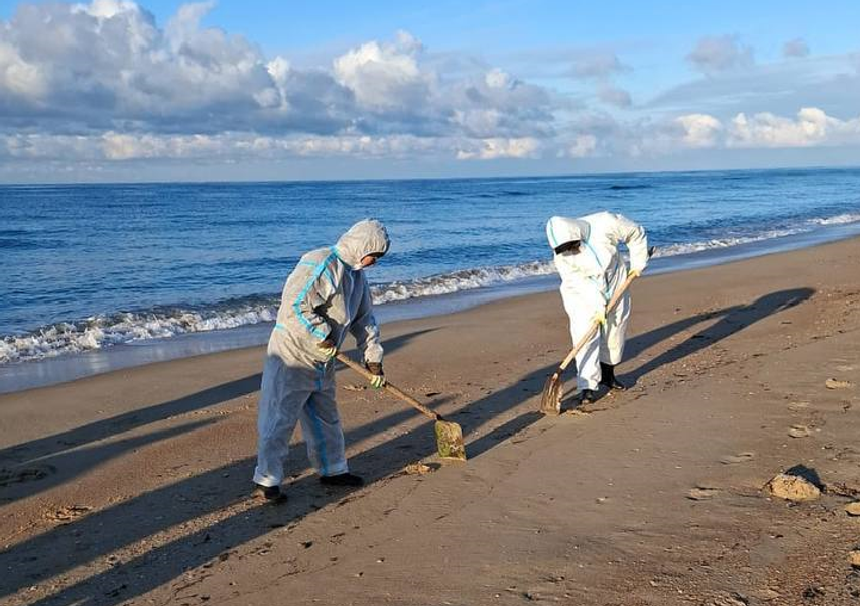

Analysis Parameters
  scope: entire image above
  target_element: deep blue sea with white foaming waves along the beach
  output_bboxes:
[0,169,860,392]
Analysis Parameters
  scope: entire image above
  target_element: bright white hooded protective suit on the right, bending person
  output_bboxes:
[546,212,648,390]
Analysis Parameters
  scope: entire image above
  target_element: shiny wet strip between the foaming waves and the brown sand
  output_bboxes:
[0,217,860,394]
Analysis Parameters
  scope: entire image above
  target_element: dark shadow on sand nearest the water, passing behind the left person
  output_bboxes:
[0,329,435,504]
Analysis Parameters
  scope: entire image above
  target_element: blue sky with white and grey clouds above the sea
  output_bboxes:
[0,0,860,183]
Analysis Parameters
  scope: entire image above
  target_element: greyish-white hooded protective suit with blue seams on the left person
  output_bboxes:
[254,219,389,486]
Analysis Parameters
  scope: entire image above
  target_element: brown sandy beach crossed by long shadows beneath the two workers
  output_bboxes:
[0,239,860,606]
